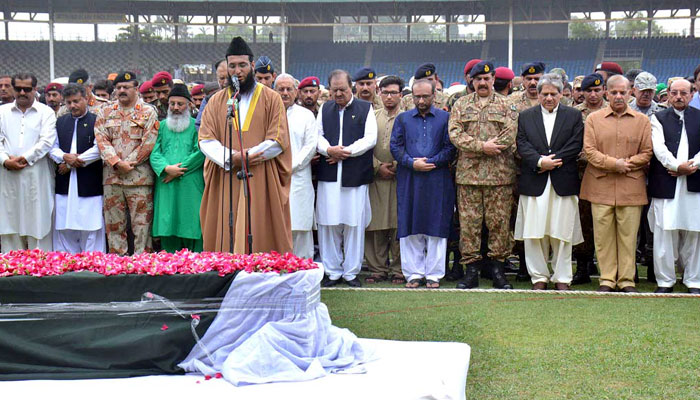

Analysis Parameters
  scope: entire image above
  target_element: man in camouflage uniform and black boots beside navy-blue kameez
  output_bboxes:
[449,61,518,289]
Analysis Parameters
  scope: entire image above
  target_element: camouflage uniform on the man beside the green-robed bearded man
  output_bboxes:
[95,99,160,255]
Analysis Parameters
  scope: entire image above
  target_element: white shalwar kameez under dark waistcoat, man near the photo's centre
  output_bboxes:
[316,99,377,281]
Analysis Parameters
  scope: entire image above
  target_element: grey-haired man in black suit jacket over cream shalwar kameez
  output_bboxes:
[515,74,583,290]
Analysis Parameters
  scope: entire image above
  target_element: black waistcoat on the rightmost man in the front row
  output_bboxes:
[649,107,700,199]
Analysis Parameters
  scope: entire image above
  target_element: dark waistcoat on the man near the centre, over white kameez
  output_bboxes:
[316,99,374,187]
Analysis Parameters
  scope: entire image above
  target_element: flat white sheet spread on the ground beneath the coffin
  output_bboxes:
[0,339,471,400]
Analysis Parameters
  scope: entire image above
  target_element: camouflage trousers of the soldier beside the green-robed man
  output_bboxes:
[104,185,153,255]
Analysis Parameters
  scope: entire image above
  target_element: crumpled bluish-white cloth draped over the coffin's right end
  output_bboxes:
[178,268,370,386]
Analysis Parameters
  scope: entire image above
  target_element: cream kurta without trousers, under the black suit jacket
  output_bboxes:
[515,108,583,245]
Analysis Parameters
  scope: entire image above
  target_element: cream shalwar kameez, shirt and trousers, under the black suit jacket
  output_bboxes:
[515,107,583,285]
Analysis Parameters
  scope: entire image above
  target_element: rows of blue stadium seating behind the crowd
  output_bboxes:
[0,37,700,85]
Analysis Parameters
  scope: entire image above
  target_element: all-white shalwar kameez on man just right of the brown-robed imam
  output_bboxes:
[287,104,318,258]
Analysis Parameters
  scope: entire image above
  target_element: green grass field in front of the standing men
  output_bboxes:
[322,268,700,399]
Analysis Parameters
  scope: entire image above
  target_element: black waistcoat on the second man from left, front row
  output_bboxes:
[56,112,103,197]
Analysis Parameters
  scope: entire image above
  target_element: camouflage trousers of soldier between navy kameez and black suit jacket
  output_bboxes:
[457,185,513,264]
